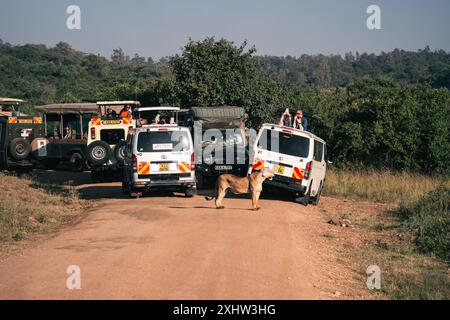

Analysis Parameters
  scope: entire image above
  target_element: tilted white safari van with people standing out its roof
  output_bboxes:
[248,124,327,205]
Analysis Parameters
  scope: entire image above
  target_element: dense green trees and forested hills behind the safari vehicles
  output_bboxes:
[0,38,450,174]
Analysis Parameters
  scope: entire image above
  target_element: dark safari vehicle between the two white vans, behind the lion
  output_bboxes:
[185,106,248,188]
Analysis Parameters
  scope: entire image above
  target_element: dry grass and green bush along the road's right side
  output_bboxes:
[328,184,450,299]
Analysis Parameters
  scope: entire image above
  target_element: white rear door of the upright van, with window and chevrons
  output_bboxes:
[136,128,193,175]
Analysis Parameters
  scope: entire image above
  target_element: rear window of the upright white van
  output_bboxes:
[137,131,190,152]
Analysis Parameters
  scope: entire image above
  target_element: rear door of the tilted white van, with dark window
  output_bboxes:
[252,128,310,179]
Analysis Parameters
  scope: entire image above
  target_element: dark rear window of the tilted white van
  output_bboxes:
[258,129,309,158]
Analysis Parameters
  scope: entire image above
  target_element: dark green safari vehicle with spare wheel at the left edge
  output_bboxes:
[0,98,45,173]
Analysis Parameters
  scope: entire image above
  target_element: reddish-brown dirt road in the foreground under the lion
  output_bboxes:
[0,171,374,299]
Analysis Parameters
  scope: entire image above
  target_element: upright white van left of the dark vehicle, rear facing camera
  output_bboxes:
[122,124,197,197]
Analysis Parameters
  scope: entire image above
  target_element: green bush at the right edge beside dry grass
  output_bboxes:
[399,186,450,262]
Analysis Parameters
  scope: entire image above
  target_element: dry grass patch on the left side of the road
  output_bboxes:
[0,173,89,244]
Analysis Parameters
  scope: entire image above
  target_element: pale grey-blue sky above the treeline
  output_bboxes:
[0,0,450,59]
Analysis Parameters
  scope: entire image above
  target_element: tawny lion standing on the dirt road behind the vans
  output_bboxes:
[205,168,274,211]
